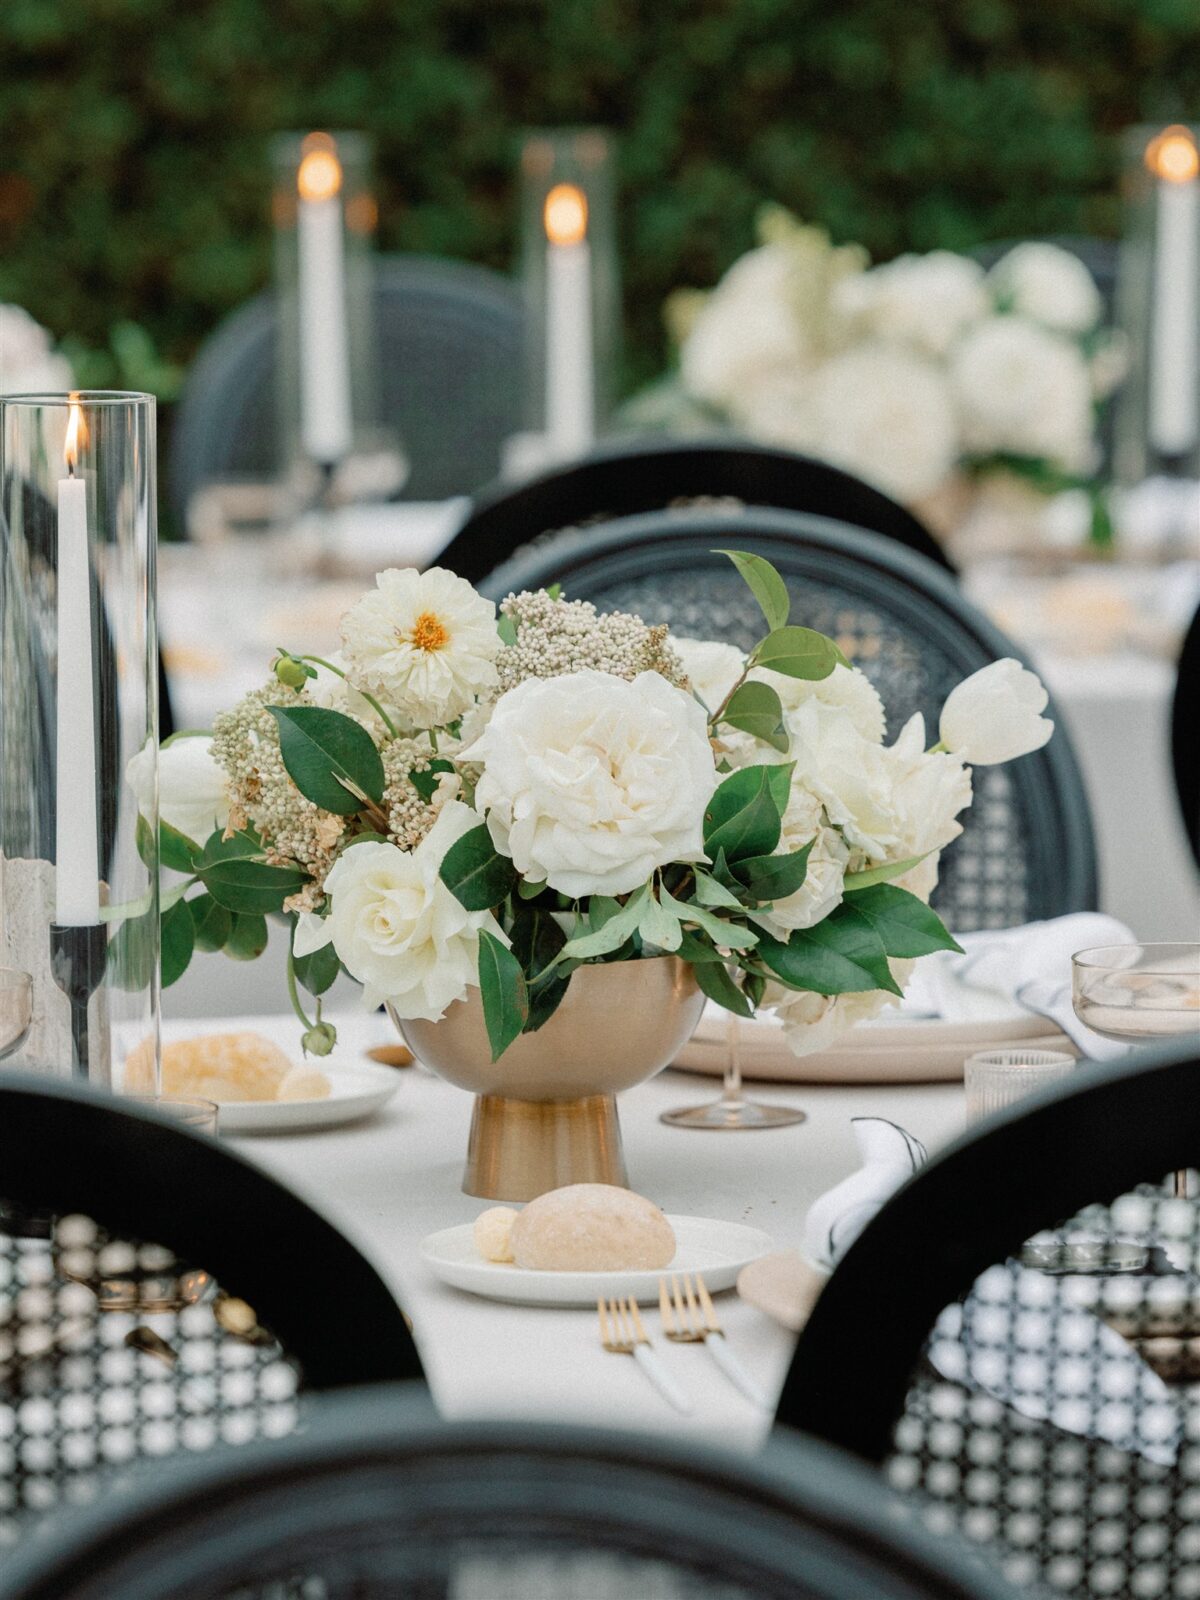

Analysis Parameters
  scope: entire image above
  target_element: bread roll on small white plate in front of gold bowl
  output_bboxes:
[512,1184,675,1272]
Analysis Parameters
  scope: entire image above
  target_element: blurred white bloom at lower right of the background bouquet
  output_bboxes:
[950,317,1094,472]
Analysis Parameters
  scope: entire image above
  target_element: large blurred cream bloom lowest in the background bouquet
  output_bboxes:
[787,342,958,501]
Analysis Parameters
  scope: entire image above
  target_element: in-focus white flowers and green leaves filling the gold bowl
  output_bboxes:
[148,552,1051,1061]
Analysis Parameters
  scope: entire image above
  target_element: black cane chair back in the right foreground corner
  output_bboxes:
[778,1040,1200,1600]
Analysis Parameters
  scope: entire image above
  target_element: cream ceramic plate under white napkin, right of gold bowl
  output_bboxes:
[674,1006,1074,1083]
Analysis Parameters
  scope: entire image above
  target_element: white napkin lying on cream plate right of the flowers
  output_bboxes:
[899,912,1133,1061]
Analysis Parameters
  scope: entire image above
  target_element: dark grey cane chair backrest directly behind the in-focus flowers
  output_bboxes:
[478,506,1096,931]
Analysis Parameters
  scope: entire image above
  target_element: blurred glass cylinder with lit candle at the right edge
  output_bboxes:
[1115,123,1200,483]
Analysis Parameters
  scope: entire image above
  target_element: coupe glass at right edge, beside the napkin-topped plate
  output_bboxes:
[1070,941,1200,1198]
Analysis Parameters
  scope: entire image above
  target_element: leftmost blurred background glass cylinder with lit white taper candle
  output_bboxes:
[272,133,395,499]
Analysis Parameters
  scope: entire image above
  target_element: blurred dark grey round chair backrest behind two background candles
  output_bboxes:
[170,256,523,526]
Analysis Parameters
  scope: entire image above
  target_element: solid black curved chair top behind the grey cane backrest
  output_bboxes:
[440,438,952,582]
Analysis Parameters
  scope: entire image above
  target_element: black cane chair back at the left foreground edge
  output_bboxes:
[0,1072,421,1542]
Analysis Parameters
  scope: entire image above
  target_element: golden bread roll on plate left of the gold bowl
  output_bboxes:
[125,1034,330,1104]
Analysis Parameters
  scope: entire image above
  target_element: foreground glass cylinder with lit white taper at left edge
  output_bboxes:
[0,390,158,1088]
